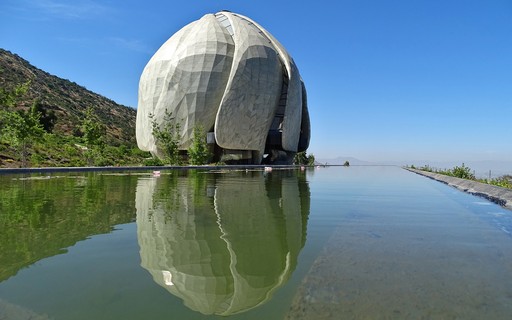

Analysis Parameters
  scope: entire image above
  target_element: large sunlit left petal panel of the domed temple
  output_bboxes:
[137,14,234,152]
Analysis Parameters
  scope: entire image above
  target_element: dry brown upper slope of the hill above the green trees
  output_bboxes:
[0,48,137,145]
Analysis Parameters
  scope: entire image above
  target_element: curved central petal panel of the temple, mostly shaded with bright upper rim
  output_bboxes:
[215,12,282,153]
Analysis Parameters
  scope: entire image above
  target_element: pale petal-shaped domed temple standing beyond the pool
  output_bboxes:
[136,11,310,164]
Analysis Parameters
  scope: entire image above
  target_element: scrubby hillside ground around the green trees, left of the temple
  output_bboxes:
[0,49,147,167]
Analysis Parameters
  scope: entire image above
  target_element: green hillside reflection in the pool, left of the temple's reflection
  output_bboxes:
[0,173,136,281]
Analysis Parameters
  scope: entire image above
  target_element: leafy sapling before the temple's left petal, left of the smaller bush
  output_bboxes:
[149,111,181,165]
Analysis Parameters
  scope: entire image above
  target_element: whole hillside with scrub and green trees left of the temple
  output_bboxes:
[0,49,149,167]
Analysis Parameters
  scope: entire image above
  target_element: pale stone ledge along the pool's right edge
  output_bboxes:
[406,168,512,210]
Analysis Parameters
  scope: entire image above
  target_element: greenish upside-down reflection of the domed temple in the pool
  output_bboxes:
[136,171,310,315]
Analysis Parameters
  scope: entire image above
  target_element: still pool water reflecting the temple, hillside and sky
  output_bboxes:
[0,167,512,319]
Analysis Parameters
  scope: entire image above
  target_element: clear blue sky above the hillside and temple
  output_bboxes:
[0,0,512,164]
